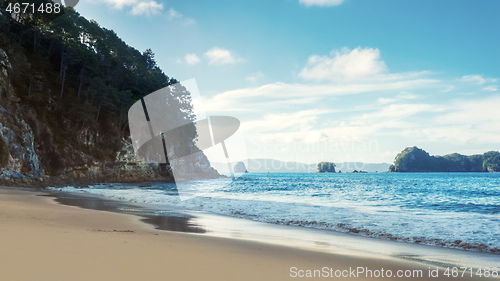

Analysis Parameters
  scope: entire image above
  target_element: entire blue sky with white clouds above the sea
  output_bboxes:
[76,0,500,163]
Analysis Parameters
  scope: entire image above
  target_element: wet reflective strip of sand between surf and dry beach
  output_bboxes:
[46,185,500,269]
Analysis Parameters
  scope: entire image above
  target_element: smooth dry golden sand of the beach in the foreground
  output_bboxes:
[0,187,492,281]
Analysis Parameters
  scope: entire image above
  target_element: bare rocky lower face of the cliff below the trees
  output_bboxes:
[0,49,218,186]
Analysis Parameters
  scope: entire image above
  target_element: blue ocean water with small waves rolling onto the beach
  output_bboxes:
[49,173,500,253]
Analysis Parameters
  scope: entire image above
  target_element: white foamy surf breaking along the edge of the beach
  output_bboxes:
[44,177,500,256]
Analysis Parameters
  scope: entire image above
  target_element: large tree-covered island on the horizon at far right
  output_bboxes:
[389,146,500,172]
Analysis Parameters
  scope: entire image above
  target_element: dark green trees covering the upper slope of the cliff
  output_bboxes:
[0,3,196,171]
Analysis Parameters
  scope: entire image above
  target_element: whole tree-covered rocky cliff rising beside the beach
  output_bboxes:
[0,6,218,185]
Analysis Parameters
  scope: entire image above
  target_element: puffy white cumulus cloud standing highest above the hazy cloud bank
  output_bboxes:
[299,47,387,81]
